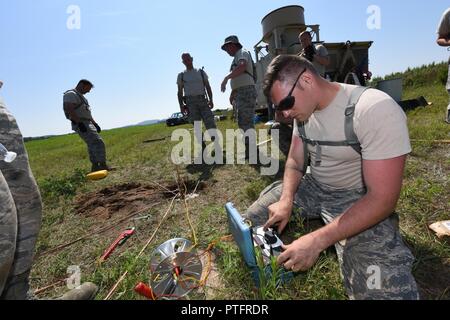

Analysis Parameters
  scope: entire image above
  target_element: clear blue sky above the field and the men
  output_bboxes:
[0,0,449,136]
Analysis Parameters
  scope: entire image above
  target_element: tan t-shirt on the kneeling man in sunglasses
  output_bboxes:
[294,84,411,189]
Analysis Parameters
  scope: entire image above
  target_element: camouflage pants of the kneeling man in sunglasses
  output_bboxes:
[244,175,419,300]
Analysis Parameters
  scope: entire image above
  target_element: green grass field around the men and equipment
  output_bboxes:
[26,64,450,300]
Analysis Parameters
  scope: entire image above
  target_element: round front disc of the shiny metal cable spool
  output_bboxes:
[150,252,203,300]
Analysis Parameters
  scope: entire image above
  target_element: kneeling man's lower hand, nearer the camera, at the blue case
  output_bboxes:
[277,234,324,272]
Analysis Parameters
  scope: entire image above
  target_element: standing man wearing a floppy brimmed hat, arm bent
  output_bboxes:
[221,36,257,159]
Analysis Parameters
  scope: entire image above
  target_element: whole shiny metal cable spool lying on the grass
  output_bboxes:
[150,238,203,300]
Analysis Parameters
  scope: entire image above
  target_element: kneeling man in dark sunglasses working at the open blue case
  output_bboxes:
[244,55,419,299]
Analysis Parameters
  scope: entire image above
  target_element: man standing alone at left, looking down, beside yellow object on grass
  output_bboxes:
[64,79,110,172]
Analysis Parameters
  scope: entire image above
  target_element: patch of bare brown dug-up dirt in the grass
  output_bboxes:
[75,181,204,220]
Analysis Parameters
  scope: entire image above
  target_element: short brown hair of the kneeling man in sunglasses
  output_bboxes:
[263,54,319,98]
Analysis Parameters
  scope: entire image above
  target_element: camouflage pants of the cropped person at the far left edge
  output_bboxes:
[0,99,42,300]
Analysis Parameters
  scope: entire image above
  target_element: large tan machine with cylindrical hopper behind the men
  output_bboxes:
[254,5,373,113]
